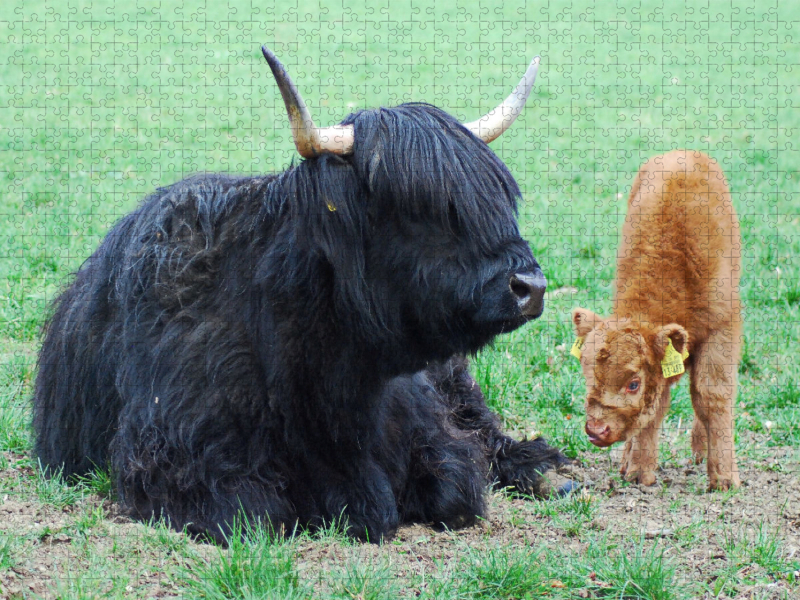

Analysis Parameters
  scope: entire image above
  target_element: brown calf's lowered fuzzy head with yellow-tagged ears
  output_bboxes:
[572,308,689,447]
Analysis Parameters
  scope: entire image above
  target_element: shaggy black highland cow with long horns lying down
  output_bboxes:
[34,50,571,541]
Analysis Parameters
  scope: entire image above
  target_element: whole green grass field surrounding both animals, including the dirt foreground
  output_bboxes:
[0,0,800,599]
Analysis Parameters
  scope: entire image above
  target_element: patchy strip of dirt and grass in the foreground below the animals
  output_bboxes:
[0,432,800,600]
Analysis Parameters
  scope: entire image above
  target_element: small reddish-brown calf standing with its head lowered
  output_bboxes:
[572,150,741,489]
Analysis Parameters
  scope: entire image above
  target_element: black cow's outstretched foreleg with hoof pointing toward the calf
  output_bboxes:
[431,357,577,497]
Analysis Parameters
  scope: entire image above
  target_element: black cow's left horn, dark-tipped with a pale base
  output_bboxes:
[261,46,355,158]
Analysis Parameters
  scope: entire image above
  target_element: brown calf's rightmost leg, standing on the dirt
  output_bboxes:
[690,329,741,490]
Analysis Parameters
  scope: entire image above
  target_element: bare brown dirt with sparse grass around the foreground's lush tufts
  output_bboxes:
[0,436,800,598]
